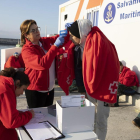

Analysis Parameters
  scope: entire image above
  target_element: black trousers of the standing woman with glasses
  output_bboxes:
[25,89,54,108]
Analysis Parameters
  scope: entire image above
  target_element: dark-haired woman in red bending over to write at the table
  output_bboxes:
[0,67,34,140]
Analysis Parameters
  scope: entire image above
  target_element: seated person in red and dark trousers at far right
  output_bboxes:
[115,61,139,107]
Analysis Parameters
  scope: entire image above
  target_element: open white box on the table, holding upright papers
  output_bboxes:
[56,99,95,134]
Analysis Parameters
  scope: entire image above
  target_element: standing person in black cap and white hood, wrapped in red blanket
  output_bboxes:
[68,19,119,140]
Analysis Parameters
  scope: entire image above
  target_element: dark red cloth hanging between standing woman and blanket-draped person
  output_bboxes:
[56,41,75,95]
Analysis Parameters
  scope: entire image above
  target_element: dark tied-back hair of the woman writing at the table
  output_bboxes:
[0,67,30,87]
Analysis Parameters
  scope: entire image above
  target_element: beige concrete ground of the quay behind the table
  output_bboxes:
[17,86,140,140]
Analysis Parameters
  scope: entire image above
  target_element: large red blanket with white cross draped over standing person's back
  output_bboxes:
[82,27,120,103]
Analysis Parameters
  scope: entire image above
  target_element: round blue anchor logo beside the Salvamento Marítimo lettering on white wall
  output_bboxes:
[104,3,116,24]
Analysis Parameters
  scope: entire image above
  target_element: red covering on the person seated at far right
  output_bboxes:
[119,66,139,87]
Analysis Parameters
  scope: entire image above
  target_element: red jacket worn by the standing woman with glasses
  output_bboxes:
[21,36,59,91]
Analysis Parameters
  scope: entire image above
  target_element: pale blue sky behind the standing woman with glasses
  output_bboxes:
[0,0,68,39]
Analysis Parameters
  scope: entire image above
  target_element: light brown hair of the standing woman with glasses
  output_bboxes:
[20,19,37,45]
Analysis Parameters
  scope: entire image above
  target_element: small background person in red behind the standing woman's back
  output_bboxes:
[4,52,25,71]
